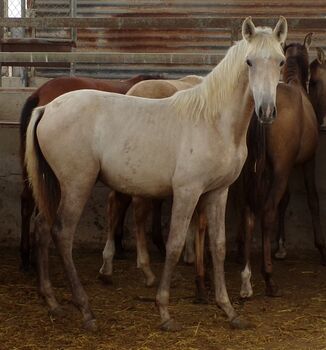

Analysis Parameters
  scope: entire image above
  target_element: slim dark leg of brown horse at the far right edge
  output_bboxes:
[303,157,326,265]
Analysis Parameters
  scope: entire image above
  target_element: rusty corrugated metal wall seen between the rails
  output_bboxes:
[30,0,326,77]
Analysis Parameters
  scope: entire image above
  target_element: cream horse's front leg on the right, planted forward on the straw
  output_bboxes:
[204,189,251,329]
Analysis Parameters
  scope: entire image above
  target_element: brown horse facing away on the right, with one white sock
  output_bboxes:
[240,35,326,297]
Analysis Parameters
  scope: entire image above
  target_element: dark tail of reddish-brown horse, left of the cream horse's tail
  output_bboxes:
[19,93,39,174]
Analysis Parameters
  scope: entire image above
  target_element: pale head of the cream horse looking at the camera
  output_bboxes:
[242,16,287,124]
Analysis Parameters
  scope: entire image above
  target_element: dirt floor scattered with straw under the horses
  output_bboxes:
[0,250,326,350]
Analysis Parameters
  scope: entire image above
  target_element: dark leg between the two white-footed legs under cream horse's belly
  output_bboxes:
[113,192,131,259]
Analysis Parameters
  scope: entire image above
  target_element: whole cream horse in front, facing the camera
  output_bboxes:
[26,17,287,330]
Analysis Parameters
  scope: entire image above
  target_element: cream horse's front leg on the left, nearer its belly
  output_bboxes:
[156,188,201,331]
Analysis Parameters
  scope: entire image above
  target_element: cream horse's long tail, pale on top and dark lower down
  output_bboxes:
[25,107,61,224]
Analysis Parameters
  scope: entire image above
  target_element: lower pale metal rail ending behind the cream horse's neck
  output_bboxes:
[0,51,225,65]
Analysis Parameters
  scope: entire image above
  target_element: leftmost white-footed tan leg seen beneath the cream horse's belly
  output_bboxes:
[99,191,131,284]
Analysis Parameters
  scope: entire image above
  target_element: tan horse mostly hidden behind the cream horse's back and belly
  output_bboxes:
[99,75,203,287]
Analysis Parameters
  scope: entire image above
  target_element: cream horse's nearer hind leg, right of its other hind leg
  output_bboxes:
[51,180,97,330]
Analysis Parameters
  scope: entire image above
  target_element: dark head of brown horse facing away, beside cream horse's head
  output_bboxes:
[283,33,313,90]
